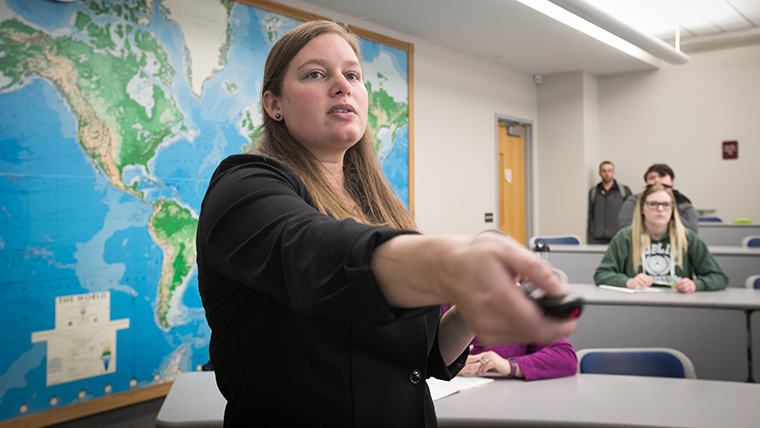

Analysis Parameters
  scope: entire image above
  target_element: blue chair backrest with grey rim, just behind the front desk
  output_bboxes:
[577,348,697,379]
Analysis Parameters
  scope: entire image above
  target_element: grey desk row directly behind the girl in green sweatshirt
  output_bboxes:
[549,245,760,288]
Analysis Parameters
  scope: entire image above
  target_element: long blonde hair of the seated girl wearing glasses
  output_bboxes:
[631,183,689,272]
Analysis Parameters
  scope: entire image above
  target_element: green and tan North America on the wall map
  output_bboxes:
[0,14,184,191]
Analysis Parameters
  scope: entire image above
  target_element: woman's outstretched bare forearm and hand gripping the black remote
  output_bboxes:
[371,233,575,349]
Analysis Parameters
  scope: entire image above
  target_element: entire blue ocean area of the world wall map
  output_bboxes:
[0,0,409,421]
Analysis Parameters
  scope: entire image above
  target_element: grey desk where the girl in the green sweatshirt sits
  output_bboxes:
[568,284,760,382]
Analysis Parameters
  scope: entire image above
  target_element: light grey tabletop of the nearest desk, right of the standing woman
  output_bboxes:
[435,374,760,428]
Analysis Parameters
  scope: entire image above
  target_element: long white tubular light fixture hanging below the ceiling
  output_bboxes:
[517,0,689,67]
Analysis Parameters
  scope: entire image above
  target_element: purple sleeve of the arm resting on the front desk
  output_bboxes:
[514,338,578,380]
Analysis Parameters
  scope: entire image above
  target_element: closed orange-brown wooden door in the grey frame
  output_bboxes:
[498,122,526,245]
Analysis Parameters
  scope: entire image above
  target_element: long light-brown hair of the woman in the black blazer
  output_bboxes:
[250,21,417,230]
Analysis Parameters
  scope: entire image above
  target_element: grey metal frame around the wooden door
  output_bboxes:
[493,114,535,245]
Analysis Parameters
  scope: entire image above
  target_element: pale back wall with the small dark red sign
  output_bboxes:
[600,46,760,222]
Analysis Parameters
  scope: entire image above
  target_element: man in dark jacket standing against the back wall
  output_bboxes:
[586,161,631,244]
